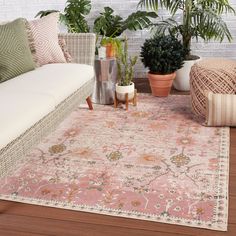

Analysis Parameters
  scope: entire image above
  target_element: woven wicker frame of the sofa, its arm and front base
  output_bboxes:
[0,33,95,177]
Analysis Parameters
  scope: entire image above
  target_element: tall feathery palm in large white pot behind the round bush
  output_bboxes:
[139,0,235,91]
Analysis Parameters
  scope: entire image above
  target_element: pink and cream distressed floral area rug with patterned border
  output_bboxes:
[0,94,229,231]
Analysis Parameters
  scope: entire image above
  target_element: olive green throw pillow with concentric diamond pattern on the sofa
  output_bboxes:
[0,19,35,82]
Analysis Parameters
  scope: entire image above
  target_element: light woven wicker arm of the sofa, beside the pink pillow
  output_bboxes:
[59,33,96,65]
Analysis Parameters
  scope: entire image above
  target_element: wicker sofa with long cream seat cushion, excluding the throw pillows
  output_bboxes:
[0,34,95,176]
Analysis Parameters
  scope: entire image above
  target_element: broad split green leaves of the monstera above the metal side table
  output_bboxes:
[94,7,157,38]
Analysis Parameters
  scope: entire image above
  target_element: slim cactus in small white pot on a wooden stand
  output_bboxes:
[116,38,138,101]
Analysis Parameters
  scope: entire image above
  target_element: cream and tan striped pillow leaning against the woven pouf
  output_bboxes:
[206,92,236,126]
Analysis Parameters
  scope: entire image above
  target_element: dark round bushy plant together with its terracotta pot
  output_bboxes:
[141,35,187,97]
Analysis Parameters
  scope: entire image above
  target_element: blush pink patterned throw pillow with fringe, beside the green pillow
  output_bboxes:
[29,13,66,66]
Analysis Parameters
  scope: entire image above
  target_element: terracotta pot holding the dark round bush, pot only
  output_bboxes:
[148,73,176,97]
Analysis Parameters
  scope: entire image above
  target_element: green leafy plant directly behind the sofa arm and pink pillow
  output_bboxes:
[36,0,92,33]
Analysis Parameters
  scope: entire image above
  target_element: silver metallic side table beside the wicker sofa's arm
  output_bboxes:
[92,58,117,105]
